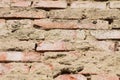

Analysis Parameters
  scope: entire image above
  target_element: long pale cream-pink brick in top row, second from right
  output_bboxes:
[71,1,106,9]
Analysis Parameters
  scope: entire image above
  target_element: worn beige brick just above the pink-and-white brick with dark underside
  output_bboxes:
[45,29,86,41]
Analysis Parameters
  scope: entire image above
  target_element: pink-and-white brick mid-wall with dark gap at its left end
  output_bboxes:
[36,41,72,51]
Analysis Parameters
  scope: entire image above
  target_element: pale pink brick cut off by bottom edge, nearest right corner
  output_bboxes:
[91,74,119,80]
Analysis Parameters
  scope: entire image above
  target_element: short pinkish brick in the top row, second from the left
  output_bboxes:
[11,0,31,7]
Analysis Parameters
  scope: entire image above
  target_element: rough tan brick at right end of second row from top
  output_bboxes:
[85,9,120,19]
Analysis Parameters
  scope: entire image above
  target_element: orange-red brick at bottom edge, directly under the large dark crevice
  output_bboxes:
[55,74,87,80]
